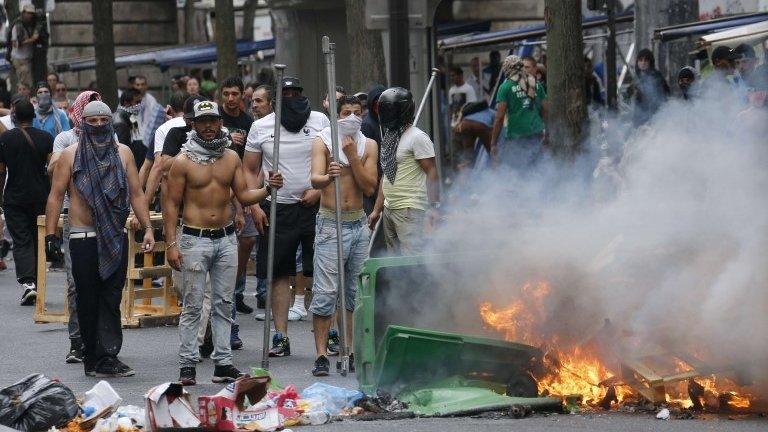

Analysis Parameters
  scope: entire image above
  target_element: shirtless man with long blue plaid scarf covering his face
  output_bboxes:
[45,101,155,377]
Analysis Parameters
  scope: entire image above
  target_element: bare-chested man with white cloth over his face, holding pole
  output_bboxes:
[309,96,378,376]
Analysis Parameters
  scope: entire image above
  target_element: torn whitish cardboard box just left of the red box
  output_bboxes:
[144,383,200,432]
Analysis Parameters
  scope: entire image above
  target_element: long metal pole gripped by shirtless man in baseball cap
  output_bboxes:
[261,64,285,369]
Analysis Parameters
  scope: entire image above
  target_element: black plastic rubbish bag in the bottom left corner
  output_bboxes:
[0,374,80,431]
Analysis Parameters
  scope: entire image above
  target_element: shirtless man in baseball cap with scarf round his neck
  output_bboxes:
[163,101,283,385]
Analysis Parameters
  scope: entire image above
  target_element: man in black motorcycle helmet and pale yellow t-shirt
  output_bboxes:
[368,87,440,255]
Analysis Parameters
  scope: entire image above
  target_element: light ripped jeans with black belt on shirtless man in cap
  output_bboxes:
[179,234,237,367]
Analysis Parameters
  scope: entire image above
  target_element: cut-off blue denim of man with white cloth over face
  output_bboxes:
[309,214,371,316]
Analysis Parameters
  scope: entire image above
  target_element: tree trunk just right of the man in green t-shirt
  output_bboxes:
[544,0,587,158]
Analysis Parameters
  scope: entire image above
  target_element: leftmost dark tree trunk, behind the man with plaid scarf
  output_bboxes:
[91,0,117,109]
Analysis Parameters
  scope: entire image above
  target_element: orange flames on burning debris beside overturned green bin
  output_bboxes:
[479,281,752,410]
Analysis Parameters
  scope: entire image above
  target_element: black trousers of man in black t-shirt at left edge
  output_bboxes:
[3,203,45,283]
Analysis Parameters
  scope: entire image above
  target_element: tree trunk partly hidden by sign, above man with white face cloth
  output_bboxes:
[345,0,387,90]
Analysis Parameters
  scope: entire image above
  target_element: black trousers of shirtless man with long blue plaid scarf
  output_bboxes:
[69,236,128,370]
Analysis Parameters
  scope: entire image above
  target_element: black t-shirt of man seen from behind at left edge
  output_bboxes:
[0,127,53,204]
